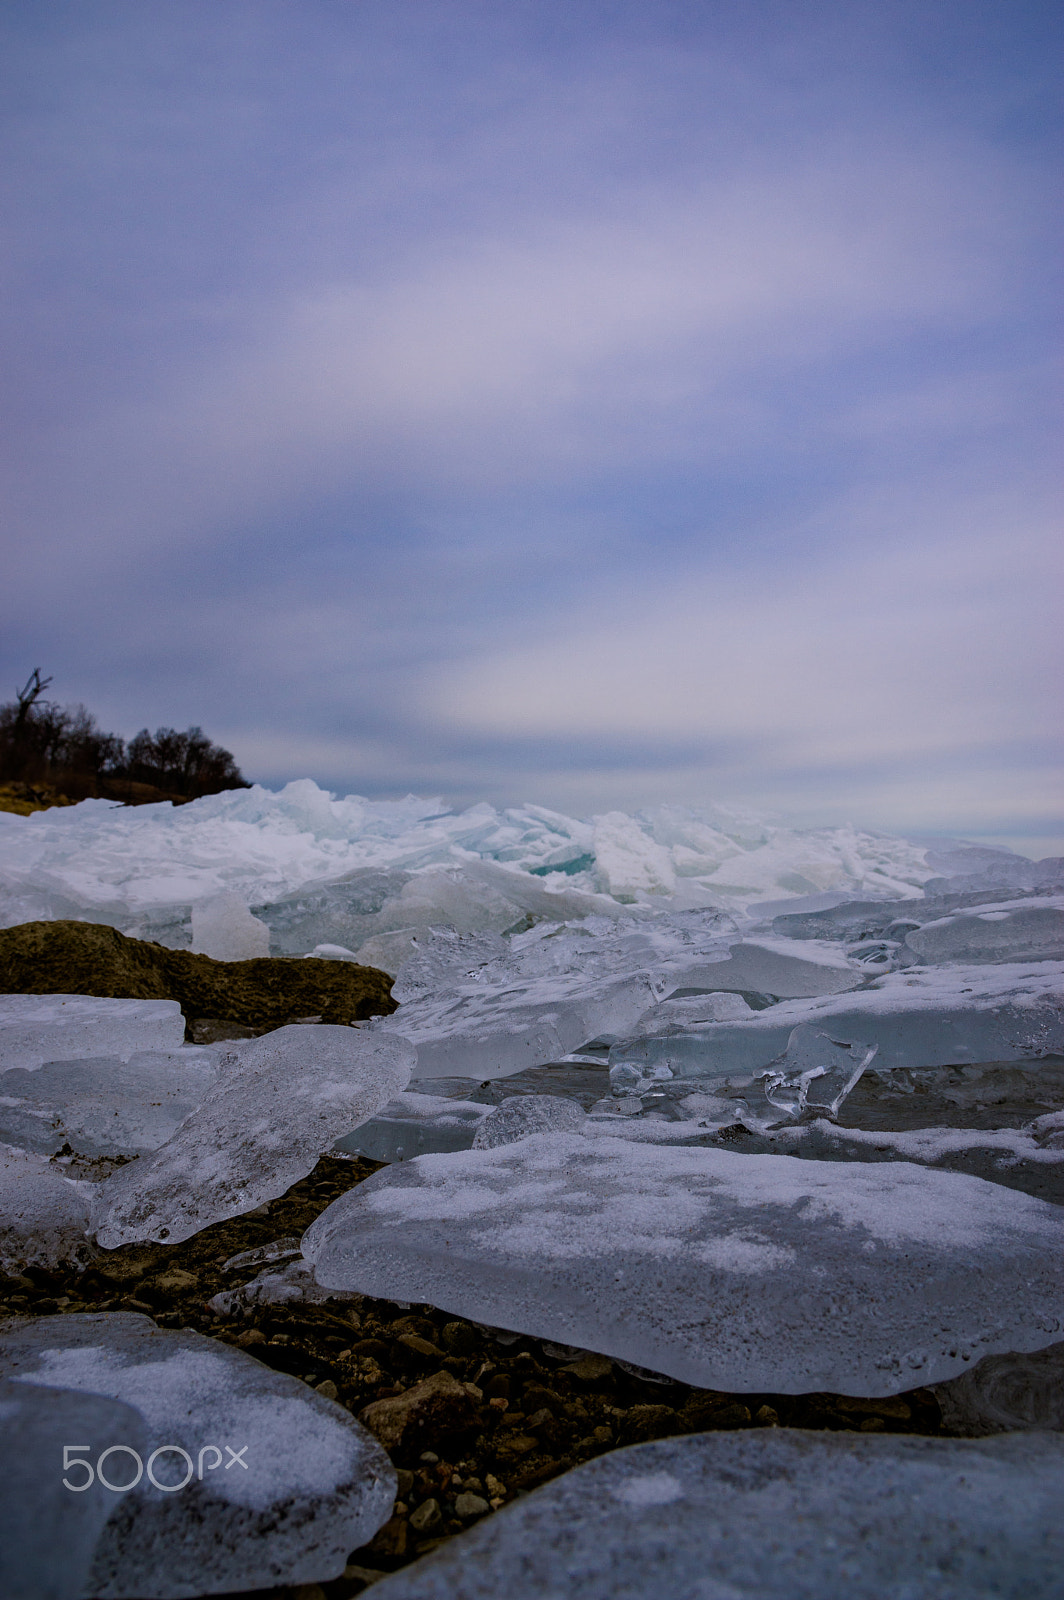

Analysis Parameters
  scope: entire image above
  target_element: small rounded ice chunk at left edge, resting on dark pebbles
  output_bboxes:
[0,1146,94,1275]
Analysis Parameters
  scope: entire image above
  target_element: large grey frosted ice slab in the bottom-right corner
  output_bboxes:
[368,1429,1064,1600]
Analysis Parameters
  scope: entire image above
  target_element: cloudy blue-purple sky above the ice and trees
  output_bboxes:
[0,0,1064,854]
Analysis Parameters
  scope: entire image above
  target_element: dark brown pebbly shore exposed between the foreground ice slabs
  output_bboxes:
[0,1157,941,1600]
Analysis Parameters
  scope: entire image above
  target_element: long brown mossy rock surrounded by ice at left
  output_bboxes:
[0,922,395,1030]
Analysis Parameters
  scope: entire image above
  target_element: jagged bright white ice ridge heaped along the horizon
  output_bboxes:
[0,779,947,952]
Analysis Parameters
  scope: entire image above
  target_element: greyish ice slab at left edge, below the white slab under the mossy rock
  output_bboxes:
[0,1045,218,1157]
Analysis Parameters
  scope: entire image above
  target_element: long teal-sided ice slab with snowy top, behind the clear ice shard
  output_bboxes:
[610,962,1064,1082]
